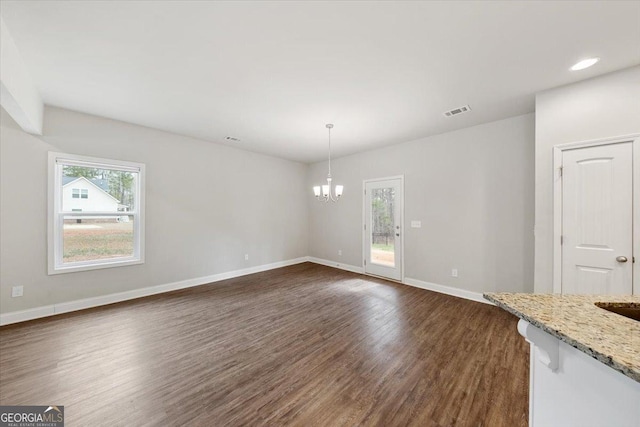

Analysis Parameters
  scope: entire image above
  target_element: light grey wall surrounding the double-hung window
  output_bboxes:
[0,108,308,313]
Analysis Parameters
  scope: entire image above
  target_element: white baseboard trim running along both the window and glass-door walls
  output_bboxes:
[0,257,491,326]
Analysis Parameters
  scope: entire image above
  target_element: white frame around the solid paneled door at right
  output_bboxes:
[553,134,640,295]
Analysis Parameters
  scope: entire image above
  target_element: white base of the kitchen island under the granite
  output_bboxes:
[518,320,640,427]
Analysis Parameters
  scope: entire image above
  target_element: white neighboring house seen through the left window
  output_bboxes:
[62,176,128,219]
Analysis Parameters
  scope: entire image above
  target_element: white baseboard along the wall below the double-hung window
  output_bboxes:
[0,257,309,326]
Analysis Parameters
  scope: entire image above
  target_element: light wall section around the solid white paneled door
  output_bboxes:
[535,67,640,293]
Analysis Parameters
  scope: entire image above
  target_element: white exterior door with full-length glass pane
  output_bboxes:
[364,178,403,281]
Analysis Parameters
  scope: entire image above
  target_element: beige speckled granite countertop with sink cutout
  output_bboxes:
[484,293,640,382]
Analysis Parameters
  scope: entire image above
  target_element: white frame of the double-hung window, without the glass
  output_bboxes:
[47,152,145,275]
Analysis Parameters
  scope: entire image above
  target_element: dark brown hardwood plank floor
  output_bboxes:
[0,263,529,426]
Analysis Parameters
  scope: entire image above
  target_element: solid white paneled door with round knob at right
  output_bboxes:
[561,142,633,294]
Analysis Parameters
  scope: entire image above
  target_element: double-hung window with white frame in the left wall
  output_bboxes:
[48,152,144,274]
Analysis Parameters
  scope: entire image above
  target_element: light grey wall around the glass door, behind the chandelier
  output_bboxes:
[308,114,534,292]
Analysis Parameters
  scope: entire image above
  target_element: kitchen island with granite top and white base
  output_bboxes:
[484,293,640,427]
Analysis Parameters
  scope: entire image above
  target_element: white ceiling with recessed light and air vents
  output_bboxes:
[0,0,640,162]
